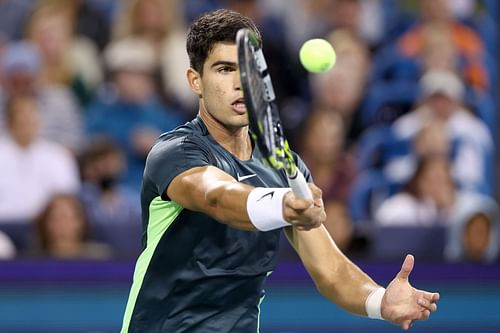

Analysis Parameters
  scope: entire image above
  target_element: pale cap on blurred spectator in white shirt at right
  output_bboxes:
[420,70,464,101]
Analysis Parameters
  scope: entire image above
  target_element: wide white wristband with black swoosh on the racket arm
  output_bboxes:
[247,187,290,231]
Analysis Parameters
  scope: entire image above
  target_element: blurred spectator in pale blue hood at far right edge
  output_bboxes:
[445,198,500,262]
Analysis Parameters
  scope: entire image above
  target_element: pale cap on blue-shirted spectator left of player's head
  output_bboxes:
[104,38,156,72]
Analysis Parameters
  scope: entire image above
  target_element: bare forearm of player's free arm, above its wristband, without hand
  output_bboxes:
[285,226,379,315]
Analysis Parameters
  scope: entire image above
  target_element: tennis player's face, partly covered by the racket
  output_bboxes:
[191,43,248,131]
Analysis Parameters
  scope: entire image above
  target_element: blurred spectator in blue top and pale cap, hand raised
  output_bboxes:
[87,39,182,191]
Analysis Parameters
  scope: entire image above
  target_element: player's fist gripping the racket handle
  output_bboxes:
[283,184,326,230]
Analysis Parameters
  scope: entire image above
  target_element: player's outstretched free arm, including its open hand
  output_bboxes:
[285,193,439,329]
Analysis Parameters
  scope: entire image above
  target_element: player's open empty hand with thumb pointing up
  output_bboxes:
[381,255,439,330]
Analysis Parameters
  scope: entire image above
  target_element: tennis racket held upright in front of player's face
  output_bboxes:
[236,28,312,199]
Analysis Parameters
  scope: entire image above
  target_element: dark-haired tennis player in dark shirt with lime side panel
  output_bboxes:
[121,10,439,333]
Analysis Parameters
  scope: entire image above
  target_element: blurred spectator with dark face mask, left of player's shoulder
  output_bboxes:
[80,138,141,229]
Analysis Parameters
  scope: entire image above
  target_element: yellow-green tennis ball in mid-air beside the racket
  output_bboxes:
[299,38,337,73]
